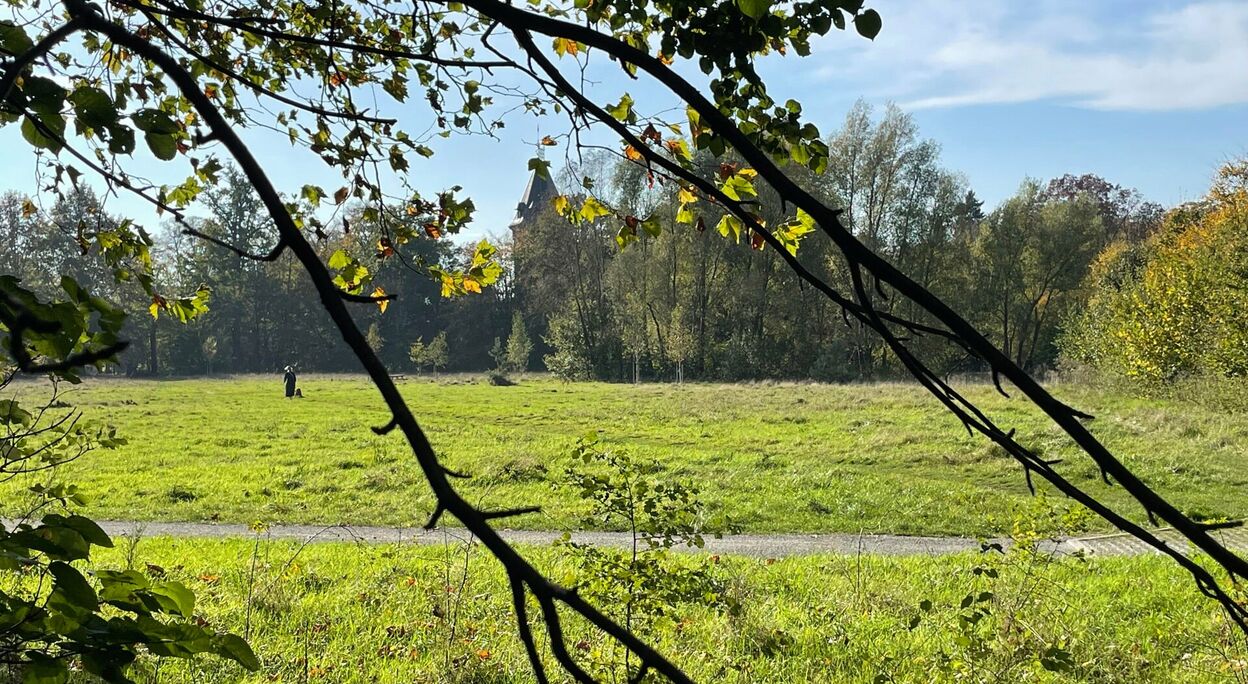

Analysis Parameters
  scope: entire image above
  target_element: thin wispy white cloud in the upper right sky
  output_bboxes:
[816,0,1248,111]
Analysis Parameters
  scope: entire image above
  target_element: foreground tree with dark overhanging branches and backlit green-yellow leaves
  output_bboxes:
[0,0,1248,683]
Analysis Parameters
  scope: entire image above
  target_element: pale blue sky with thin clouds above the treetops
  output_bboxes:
[0,0,1248,240]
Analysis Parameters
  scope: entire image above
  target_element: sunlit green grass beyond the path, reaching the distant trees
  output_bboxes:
[9,376,1248,535]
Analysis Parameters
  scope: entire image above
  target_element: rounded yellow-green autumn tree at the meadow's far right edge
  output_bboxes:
[1062,162,1248,386]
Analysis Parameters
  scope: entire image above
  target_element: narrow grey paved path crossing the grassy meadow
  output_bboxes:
[39,520,1248,558]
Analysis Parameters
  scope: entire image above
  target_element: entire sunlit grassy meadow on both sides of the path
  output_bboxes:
[4,376,1248,684]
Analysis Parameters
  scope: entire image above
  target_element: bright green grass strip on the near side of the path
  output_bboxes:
[73,538,1248,684]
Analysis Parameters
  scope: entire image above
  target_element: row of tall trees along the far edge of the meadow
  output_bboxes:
[0,102,1246,381]
